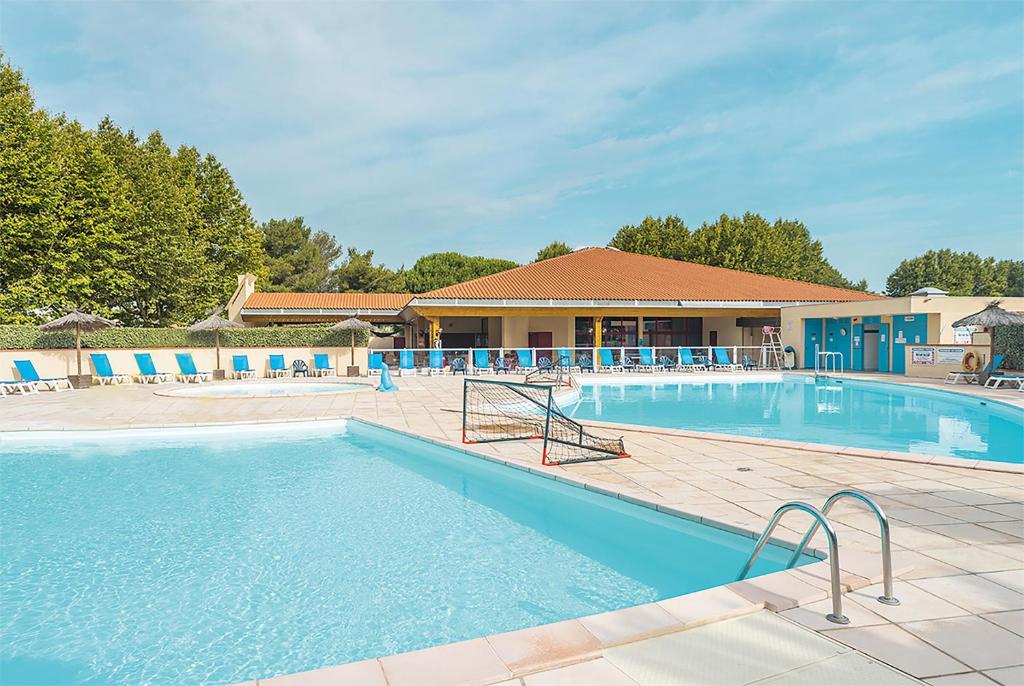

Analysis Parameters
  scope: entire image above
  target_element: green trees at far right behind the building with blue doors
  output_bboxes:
[886,249,1024,297]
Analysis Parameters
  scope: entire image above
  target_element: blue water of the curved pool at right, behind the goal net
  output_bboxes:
[565,375,1024,463]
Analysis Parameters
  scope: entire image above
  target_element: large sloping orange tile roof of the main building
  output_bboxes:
[420,248,881,302]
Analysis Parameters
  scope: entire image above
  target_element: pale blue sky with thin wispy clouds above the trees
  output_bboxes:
[0,0,1024,289]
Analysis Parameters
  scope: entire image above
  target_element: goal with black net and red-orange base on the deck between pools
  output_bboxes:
[462,379,629,466]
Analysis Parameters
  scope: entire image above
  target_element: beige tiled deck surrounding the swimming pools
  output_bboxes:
[0,373,1024,686]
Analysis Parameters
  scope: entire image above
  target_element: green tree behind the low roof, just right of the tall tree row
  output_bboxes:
[260,217,341,293]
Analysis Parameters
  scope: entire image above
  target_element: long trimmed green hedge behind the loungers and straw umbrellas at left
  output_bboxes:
[0,326,369,350]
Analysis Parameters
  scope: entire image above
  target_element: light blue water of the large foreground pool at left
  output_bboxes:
[0,423,798,685]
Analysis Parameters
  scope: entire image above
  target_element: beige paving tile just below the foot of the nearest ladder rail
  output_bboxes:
[827,625,970,678]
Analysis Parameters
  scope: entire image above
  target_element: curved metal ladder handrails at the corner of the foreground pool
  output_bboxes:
[738,488,899,625]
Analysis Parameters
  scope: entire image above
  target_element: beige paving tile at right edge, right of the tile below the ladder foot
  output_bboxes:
[902,616,1024,670]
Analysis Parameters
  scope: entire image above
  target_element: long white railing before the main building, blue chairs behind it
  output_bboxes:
[369,345,772,374]
